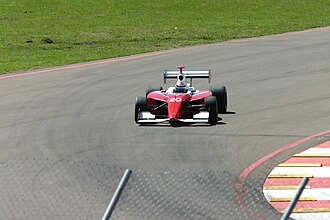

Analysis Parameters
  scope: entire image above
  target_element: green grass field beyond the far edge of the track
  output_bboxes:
[0,0,330,73]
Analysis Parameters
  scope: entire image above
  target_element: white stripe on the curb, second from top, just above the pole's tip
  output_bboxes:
[269,167,330,177]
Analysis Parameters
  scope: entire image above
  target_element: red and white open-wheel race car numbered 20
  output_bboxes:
[134,66,227,125]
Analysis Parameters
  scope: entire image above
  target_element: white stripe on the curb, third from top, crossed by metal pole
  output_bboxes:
[263,188,330,201]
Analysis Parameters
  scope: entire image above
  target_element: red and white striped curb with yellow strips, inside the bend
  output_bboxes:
[263,141,330,219]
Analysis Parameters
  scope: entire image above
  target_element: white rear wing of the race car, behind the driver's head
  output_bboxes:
[163,70,211,84]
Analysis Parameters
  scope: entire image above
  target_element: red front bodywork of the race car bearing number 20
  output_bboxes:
[147,91,212,121]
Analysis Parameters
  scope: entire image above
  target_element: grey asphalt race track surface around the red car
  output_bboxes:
[0,28,330,219]
